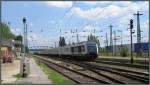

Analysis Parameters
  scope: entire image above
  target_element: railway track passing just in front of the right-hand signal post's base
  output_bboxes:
[94,60,149,69]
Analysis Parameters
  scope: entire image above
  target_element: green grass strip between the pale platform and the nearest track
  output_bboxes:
[36,60,74,84]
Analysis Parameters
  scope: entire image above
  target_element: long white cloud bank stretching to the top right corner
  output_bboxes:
[71,2,148,20]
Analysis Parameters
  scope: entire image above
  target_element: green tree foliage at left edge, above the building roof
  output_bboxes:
[0,22,15,40]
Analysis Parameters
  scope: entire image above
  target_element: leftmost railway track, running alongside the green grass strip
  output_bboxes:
[34,57,110,84]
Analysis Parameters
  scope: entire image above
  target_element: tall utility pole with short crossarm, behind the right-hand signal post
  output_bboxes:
[134,11,143,56]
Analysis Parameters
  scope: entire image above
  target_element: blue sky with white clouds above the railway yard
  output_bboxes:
[1,1,149,47]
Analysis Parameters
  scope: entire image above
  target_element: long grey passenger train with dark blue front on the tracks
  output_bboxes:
[35,41,98,60]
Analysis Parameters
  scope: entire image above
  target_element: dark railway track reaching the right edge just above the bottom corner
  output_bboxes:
[80,63,149,83]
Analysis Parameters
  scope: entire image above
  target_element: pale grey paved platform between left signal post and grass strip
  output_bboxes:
[15,58,52,84]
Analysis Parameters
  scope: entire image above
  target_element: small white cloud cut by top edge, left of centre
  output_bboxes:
[44,1,73,8]
